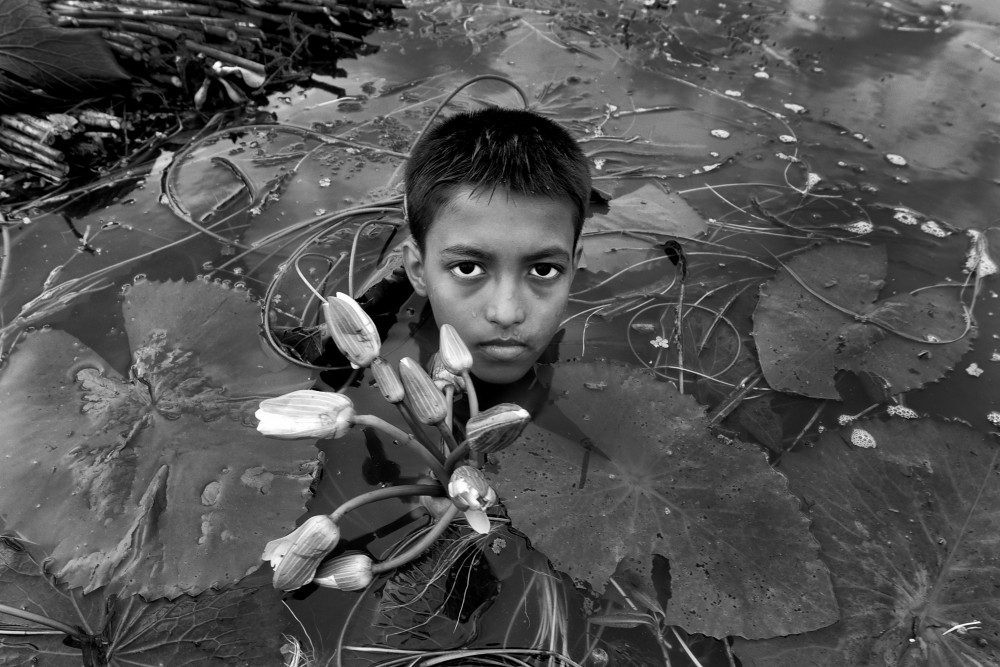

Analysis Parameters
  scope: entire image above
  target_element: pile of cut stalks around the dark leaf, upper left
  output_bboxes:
[0,0,404,204]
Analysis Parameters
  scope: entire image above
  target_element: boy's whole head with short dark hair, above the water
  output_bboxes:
[404,109,590,383]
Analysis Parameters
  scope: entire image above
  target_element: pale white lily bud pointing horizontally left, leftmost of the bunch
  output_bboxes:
[254,389,355,440]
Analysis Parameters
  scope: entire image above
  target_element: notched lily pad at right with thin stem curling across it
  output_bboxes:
[754,245,973,399]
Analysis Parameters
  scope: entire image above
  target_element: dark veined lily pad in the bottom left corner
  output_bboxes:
[0,537,284,667]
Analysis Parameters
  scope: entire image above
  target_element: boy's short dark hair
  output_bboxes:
[404,108,590,248]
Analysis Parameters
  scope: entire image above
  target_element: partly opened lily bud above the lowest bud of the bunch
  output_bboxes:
[261,514,340,591]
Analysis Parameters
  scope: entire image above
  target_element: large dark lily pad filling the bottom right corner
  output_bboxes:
[737,420,1000,667]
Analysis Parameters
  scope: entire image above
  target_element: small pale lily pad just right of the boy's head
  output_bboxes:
[581,184,708,273]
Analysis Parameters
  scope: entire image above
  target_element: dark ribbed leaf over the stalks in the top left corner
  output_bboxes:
[0,0,128,113]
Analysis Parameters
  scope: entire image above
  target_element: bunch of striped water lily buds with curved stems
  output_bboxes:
[255,293,531,591]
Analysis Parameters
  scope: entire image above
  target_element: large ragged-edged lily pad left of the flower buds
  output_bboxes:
[0,281,316,598]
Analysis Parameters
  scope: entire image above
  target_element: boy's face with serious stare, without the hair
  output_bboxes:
[403,187,580,384]
